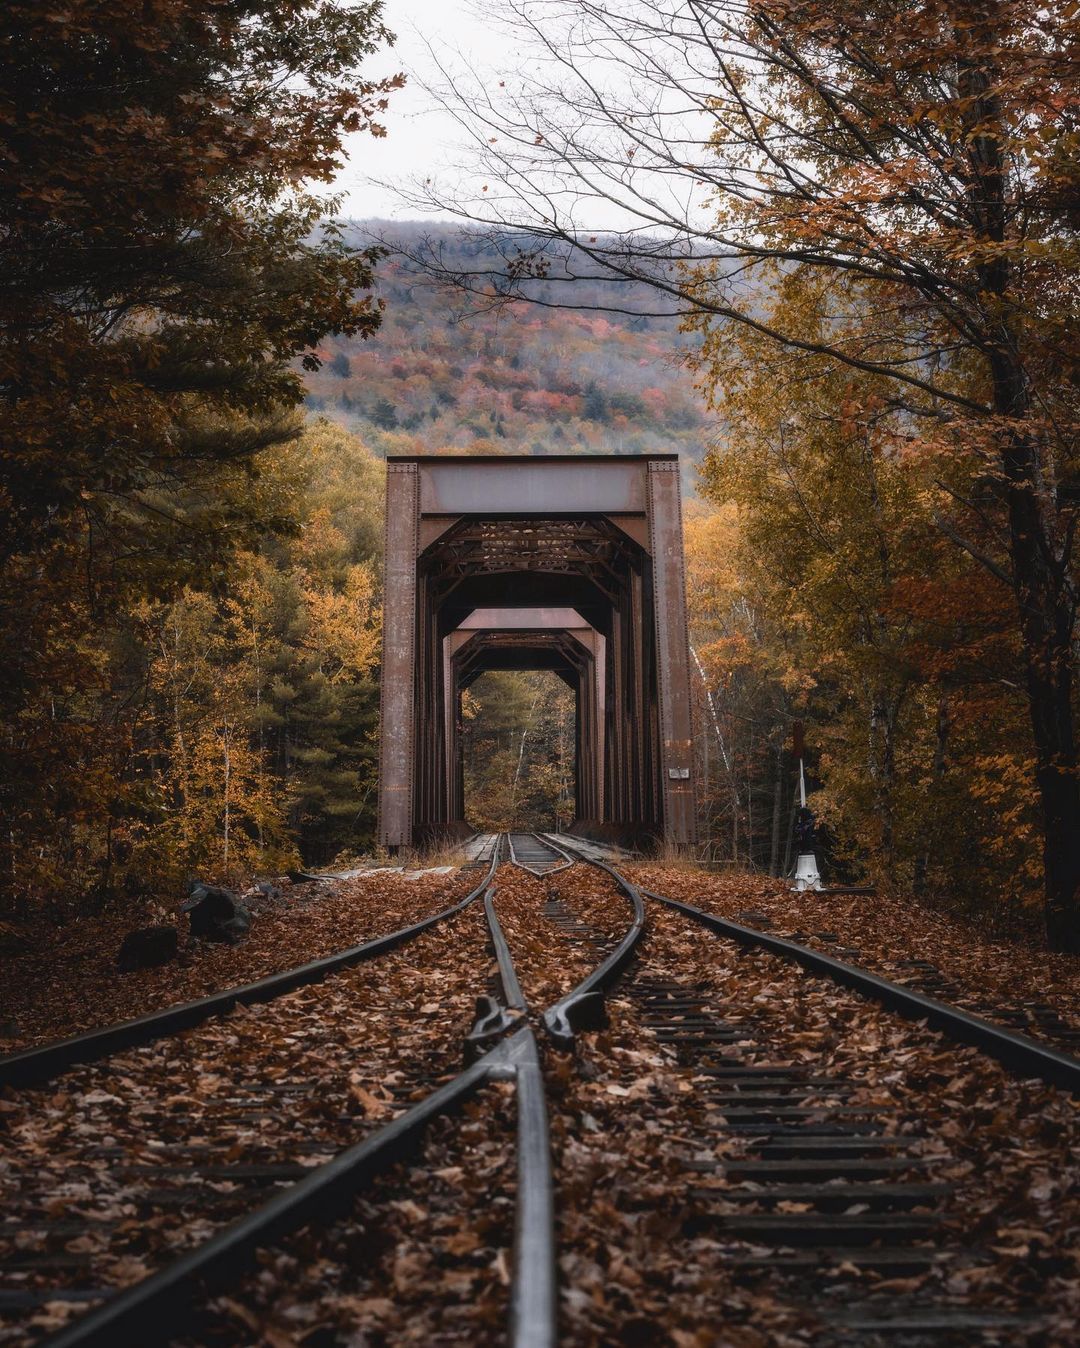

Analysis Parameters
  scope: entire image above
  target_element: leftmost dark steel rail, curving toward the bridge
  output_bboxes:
[0,843,499,1089]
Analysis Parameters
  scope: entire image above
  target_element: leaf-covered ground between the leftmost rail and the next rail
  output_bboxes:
[0,905,488,1343]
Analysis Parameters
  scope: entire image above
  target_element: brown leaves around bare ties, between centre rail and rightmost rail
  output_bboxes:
[553,872,1080,1348]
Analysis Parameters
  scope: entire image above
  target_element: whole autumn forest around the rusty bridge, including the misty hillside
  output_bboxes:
[0,0,1080,945]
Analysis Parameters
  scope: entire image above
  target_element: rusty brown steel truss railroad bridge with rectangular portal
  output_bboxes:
[379,454,696,851]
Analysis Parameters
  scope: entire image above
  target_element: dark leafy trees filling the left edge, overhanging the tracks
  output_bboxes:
[0,0,399,896]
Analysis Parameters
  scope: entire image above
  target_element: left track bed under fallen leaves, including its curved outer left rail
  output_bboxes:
[0,848,498,1341]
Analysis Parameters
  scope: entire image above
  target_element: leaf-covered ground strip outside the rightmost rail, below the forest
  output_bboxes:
[626,864,1080,1053]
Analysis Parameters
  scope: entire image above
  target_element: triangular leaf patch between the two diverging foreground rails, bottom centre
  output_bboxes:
[175,1085,514,1348]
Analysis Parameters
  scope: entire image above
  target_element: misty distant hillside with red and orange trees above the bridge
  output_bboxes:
[306,222,712,462]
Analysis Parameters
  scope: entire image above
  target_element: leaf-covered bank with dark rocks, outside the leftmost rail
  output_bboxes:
[0,871,481,1053]
